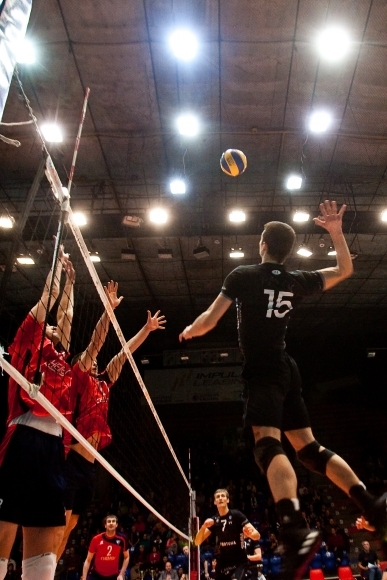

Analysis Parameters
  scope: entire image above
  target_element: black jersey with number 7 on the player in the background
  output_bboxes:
[208,510,248,573]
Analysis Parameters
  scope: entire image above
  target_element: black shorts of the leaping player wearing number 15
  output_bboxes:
[242,351,310,431]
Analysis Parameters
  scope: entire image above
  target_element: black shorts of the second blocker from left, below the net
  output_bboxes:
[64,449,95,515]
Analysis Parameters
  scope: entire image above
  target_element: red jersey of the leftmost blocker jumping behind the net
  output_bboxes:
[8,313,72,422]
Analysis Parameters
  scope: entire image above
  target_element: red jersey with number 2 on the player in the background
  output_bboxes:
[89,533,126,576]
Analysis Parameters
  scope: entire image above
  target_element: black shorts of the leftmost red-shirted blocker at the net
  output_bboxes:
[0,425,65,528]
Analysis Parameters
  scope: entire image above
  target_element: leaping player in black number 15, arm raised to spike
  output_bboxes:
[179,201,386,580]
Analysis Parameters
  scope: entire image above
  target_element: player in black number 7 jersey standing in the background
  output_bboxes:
[195,489,262,580]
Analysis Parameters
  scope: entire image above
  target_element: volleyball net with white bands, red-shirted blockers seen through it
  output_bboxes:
[0,82,192,539]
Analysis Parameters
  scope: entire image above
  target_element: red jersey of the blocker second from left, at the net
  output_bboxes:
[72,363,113,450]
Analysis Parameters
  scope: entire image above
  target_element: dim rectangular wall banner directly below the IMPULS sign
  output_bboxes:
[144,366,243,405]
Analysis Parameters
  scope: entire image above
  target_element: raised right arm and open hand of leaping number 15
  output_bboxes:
[313,200,353,290]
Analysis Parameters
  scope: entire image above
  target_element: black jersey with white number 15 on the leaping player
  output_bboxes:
[221,262,324,361]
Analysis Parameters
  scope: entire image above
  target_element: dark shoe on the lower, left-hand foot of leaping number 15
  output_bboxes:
[278,528,321,580]
